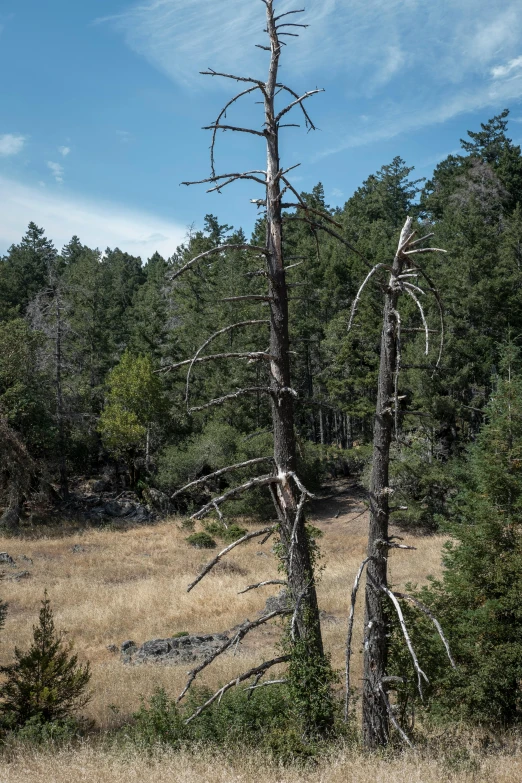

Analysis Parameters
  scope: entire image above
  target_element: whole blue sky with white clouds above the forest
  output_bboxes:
[0,0,522,258]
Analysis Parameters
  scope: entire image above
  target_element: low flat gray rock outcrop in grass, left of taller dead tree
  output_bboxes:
[122,633,229,664]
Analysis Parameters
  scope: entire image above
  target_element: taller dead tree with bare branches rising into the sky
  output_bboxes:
[161,0,335,732]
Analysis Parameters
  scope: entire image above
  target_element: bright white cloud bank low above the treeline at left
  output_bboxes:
[0,176,186,259]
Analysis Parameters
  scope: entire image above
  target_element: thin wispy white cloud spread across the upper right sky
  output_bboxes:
[98,0,522,149]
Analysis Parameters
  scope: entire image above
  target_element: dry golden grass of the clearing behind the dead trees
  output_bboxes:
[0,496,441,729]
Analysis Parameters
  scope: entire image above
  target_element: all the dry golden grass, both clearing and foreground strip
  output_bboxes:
[0,480,522,783]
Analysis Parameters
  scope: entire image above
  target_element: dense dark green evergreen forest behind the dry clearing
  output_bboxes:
[0,102,522,755]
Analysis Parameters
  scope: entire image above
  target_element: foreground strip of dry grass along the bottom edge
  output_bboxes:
[0,746,522,783]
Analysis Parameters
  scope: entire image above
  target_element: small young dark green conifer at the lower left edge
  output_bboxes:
[0,593,91,729]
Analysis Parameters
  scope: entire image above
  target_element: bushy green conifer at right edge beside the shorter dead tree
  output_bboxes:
[386,364,522,724]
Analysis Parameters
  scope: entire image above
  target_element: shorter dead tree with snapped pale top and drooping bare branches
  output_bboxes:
[345,218,454,749]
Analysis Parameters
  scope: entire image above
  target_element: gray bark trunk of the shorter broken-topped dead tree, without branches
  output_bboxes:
[362,218,412,749]
